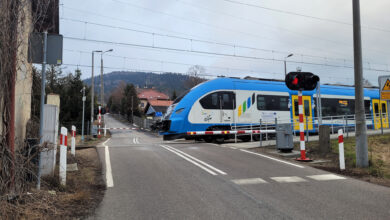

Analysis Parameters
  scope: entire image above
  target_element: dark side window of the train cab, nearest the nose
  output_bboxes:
[199,91,236,109]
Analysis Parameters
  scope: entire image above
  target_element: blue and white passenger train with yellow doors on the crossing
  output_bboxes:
[160,77,389,141]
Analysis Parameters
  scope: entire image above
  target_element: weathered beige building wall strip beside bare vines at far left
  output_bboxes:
[15,0,32,145]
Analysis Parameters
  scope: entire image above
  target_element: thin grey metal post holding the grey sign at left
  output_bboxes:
[37,31,47,190]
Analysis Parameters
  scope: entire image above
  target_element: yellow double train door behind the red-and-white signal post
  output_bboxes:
[292,95,313,130]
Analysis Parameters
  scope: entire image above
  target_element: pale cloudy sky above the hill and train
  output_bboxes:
[60,0,390,85]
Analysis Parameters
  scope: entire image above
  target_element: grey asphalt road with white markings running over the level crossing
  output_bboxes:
[92,115,390,219]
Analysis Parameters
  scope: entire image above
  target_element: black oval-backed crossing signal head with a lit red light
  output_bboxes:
[285,72,320,91]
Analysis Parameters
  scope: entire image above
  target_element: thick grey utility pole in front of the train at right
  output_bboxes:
[352,0,368,168]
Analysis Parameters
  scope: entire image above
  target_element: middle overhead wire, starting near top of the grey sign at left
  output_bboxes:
[64,37,390,72]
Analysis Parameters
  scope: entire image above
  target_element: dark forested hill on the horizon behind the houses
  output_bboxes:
[84,71,197,97]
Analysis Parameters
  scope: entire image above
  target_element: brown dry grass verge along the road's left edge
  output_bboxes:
[0,148,105,219]
